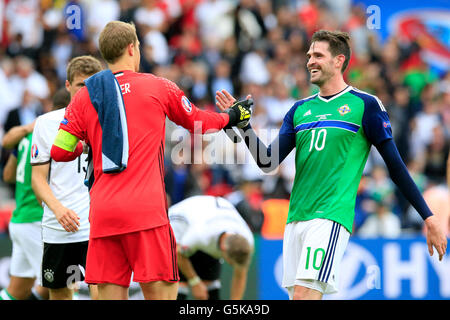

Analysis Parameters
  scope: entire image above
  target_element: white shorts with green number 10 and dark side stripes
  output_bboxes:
[282,219,350,299]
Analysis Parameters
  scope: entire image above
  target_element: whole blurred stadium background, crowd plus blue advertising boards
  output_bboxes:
[0,0,450,299]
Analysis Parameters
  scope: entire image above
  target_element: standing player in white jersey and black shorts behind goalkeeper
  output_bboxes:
[31,56,102,300]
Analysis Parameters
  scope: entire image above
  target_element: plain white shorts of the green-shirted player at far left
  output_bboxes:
[9,221,43,278]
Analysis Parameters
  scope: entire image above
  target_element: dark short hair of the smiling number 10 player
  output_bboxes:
[311,30,352,72]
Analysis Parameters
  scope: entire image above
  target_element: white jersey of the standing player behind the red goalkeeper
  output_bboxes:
[31,108,90,243]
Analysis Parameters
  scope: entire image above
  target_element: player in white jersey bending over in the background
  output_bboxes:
[169,196,254,300]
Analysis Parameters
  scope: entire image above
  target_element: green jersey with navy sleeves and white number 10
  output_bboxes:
[280,86,392,233]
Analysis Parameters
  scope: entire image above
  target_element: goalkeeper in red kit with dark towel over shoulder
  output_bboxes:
[52,21,250,299]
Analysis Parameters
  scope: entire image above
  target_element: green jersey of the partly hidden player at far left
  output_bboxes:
[11,133,43,223]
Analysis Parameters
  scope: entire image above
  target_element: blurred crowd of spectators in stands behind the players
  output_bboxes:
[0,0,450,237]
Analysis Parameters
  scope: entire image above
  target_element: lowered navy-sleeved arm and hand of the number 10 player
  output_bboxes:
[376,139,447,260]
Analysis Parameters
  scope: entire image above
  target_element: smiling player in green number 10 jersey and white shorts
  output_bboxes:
[216,31,447,299]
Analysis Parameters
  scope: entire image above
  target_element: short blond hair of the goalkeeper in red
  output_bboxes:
[98,21,137,63]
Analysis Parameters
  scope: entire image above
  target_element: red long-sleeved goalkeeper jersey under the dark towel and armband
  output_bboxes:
[60,71,229,238]
